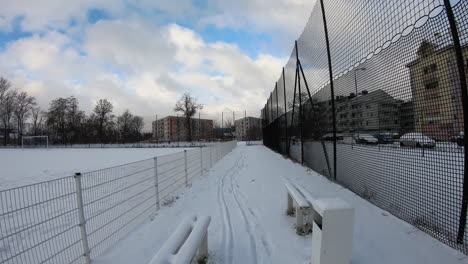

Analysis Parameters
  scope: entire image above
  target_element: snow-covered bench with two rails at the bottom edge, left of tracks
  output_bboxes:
[149,216,211,264]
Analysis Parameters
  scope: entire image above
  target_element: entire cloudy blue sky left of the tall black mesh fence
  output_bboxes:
[0,0,315,123]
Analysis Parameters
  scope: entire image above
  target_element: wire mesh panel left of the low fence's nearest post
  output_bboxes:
[0,177,84,263]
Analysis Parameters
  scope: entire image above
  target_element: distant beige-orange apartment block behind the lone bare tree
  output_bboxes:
[153,116,213,141]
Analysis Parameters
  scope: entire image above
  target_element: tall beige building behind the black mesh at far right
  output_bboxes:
[406,41,468,140]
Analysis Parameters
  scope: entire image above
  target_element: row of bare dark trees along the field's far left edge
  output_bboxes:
[0,77,144,145]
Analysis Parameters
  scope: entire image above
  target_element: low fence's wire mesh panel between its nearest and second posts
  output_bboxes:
[82,159,156,257]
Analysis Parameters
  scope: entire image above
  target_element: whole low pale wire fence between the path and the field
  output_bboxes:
[0,141,237,264]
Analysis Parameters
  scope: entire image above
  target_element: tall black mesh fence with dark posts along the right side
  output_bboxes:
[262,0,468,254]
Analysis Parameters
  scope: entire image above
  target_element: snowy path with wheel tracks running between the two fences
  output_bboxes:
[94,144,468,264]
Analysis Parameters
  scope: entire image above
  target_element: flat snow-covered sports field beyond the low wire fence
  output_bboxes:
[0,148,183,190]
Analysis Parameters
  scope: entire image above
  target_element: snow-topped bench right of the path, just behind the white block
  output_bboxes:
[284,183,311,234]
